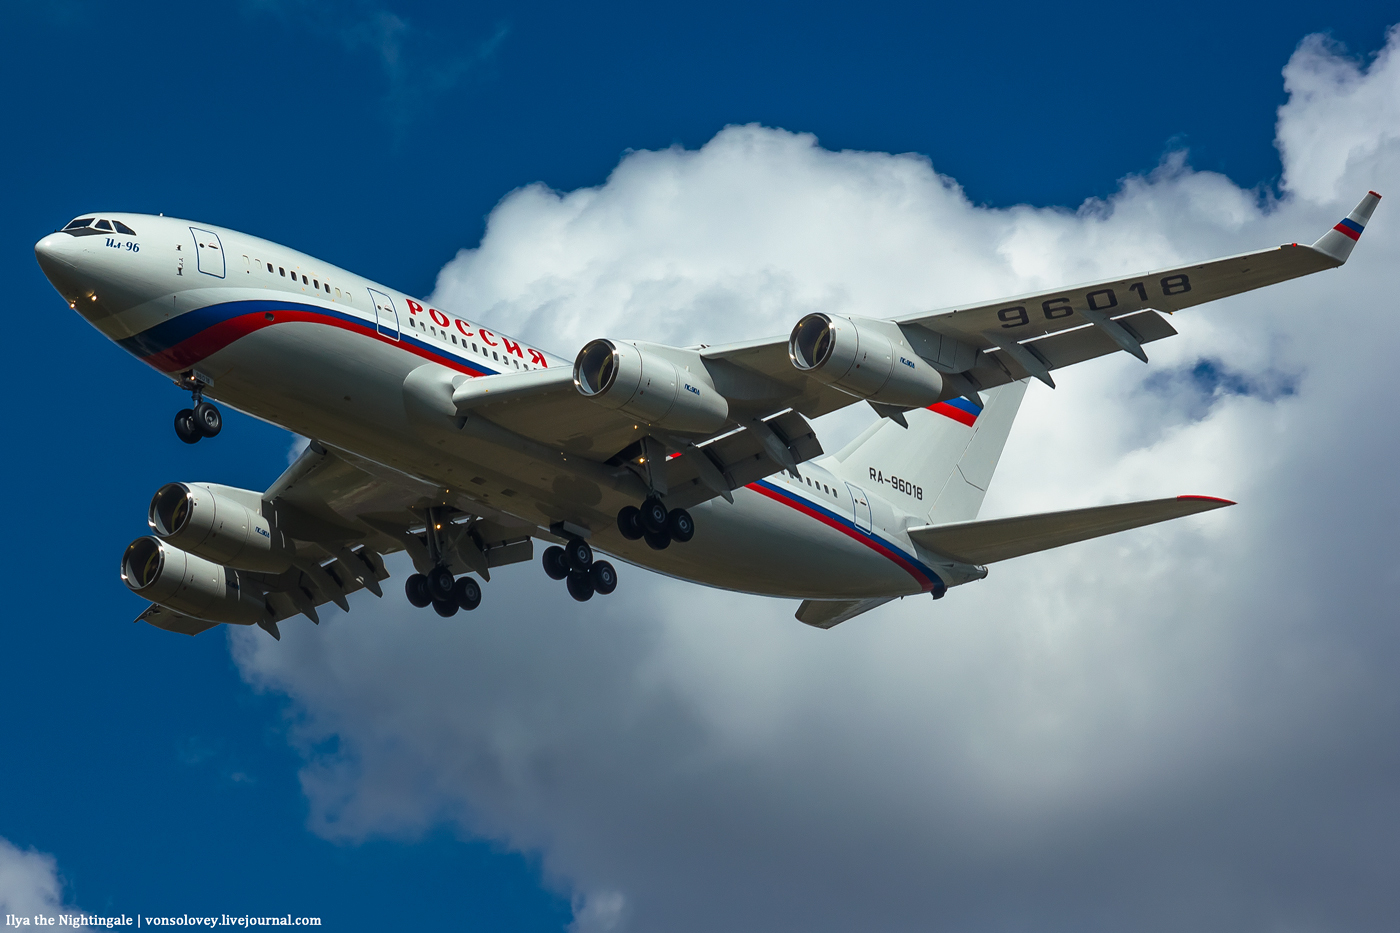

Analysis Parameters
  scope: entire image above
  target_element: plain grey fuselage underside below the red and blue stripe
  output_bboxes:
[191,322,927,598]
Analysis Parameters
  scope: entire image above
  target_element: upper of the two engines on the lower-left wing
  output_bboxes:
[147,483,293,573]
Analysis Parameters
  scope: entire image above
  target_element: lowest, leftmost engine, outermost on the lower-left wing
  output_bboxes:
[122,535,267,625]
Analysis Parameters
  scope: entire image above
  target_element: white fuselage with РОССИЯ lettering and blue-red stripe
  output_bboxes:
[36,214,967,600]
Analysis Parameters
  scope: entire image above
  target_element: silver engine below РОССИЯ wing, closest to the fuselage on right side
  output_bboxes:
[574,340,729,434]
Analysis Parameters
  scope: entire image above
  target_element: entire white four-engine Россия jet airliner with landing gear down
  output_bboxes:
[35,192,1380,639]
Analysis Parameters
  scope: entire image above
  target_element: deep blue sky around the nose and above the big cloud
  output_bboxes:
[8,0,1394,930]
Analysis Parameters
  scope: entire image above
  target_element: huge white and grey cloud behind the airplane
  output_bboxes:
[231,23,1400,932]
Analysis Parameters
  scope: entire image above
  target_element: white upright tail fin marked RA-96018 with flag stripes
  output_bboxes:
[830,380,1028,525]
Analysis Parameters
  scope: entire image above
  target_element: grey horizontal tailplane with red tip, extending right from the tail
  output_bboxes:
[901,496,1235,563]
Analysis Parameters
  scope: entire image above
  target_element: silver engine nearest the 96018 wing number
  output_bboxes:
[788,314,944,408]
